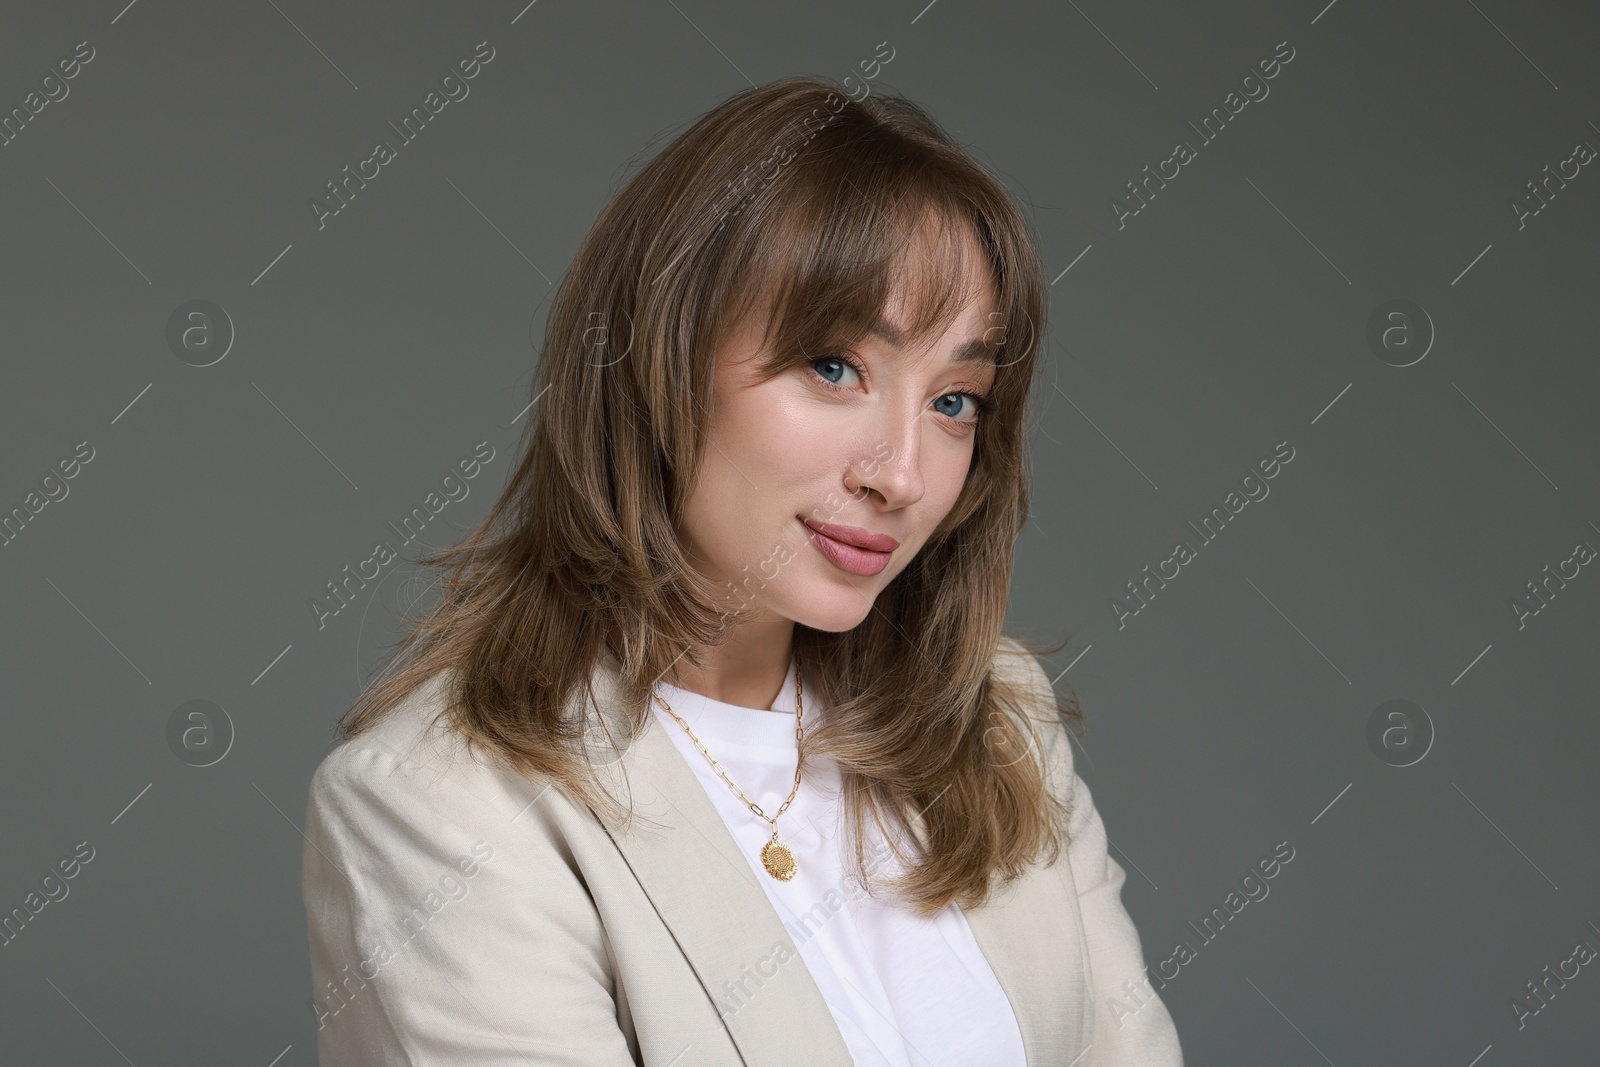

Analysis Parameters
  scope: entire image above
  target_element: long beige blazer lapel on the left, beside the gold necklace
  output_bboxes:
[576,654,854,1067]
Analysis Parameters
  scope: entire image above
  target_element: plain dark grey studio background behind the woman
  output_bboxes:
[0,0,1600,1067]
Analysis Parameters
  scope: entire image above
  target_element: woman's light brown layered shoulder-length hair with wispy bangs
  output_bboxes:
[339,78,1082,913]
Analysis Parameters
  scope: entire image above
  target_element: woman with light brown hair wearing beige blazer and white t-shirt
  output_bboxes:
[304,78,1182,1067]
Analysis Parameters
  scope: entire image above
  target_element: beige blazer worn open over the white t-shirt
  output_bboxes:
[302,645,1182,1067]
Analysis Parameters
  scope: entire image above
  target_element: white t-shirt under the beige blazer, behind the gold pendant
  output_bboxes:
[651,664,1027,1067]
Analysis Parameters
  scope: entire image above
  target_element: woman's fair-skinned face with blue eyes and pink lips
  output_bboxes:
[683,261,995,632]
